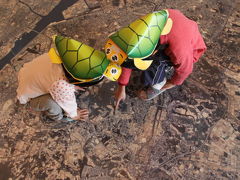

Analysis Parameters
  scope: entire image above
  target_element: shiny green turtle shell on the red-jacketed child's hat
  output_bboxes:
[110,10,168,58]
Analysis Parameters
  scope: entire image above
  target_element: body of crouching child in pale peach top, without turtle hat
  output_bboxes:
[17,53,88,120]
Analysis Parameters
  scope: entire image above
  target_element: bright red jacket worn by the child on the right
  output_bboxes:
[118,9,206,85]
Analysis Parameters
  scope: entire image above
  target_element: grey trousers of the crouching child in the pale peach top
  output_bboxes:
[29,94,63,120]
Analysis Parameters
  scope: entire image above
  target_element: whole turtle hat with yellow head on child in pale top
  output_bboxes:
[48,36,122,84]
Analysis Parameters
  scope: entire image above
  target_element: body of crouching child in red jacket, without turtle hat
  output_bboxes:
[115,9,206,108]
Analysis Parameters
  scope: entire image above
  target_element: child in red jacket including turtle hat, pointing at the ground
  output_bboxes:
[106,9,206,108]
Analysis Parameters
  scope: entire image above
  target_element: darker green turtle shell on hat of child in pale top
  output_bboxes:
[55,36,110,79]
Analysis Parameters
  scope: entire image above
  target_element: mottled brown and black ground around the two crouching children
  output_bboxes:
[0,0,240,180]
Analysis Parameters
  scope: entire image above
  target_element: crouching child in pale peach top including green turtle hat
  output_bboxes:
[17,36,121,120]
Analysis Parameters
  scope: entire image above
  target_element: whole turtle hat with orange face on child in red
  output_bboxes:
[105,10,173,70]
